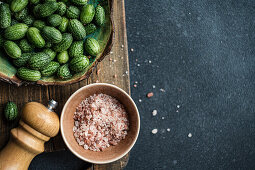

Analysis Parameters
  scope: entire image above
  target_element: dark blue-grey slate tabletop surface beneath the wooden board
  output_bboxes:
[30,0,255,170]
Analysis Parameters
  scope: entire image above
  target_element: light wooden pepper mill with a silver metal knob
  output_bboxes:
[0,100,59,170]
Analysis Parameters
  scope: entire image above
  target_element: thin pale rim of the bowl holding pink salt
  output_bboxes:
[60,83,140,164]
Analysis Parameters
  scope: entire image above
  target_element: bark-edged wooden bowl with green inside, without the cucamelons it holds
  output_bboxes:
[0,0,114,86]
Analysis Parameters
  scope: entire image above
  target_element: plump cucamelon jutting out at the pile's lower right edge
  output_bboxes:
[85,37,100,56]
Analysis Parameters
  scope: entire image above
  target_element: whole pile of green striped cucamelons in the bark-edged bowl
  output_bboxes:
[0,0,105,81]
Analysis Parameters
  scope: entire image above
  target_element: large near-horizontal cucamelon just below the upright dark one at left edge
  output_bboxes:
[4,23,28,40]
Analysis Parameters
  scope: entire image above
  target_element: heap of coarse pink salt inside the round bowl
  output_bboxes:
[73,94,129,151]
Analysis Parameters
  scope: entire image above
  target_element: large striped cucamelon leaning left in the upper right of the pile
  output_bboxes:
[68,19,86,40]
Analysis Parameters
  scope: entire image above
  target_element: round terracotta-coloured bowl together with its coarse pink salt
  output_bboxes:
[60,83,140,164]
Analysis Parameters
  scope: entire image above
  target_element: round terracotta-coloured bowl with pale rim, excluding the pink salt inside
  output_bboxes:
[60,83,140,164]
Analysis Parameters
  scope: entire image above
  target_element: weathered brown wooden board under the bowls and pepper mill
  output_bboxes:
[0,0,130,170]
